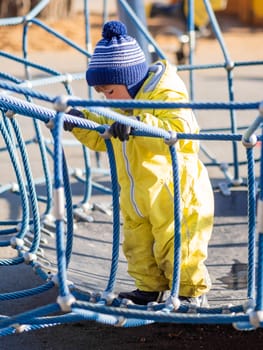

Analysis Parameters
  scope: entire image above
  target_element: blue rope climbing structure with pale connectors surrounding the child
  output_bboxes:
[0,0,263,336]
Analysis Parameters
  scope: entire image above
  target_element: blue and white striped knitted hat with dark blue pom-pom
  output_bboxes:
[86,21,148,89]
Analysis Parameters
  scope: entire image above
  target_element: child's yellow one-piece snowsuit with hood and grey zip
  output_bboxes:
[73,60,214,297]
